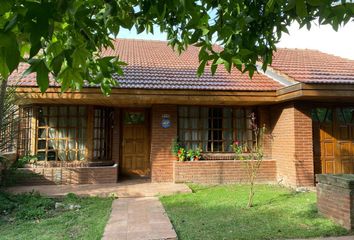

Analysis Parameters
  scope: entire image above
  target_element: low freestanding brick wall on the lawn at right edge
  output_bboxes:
[316,175,354,230]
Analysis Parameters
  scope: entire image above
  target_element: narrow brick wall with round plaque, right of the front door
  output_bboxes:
[150,105,177,182]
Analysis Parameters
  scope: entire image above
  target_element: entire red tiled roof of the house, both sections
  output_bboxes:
[10,39,354,91]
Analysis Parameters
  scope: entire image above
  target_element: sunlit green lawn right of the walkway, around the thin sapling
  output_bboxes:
[161,185,349,240]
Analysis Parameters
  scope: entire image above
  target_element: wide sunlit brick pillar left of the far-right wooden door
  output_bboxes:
[271,103,314,187]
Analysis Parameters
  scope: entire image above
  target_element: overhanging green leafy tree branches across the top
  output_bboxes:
[0,0,354,94]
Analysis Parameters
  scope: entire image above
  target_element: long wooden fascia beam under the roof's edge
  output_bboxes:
[16,83,354,107]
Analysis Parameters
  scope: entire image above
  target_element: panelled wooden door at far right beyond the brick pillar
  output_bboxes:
[313,107,354,174]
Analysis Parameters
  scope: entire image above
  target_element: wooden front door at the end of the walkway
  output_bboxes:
[120,109,150,177]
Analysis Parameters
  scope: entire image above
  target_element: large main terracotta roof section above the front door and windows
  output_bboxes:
[10,39,282,91]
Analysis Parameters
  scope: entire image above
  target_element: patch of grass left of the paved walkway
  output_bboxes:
[0,192,113,240]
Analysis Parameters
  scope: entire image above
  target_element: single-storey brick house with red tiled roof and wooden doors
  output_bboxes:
[6,40,354,187]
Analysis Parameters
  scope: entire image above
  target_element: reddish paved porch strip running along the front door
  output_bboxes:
[7,179,192,198]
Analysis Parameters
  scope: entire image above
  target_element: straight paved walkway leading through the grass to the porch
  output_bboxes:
[103,197,177,240]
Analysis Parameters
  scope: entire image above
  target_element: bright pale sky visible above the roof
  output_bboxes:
[118,22,354,60]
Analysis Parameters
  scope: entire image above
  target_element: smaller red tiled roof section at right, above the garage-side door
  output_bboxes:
[271,49,354,84]
